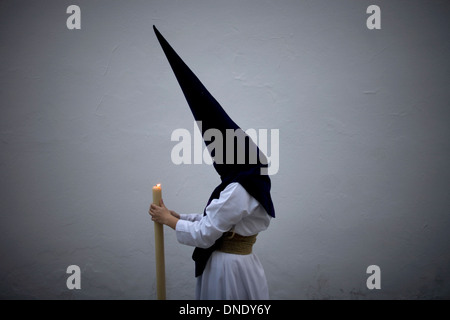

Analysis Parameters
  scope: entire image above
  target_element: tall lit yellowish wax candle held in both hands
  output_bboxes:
[152,184,166,300]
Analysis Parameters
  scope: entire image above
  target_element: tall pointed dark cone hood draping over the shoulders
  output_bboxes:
[153,26,275,276]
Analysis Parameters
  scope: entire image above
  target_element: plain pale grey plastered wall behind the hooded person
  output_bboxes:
[0,0,450,299]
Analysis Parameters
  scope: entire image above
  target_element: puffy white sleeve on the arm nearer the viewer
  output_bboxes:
[175,182,259,248]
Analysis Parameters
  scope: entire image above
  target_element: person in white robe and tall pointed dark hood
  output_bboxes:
[149,26,275,299]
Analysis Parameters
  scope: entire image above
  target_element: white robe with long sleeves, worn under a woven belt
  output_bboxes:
[175,182,271,300]
